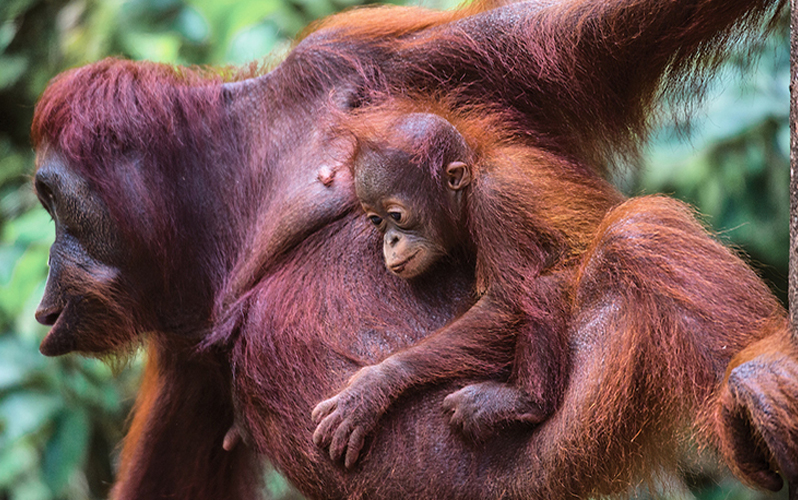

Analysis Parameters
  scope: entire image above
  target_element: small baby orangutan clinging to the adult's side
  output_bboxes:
[312,107,615,467]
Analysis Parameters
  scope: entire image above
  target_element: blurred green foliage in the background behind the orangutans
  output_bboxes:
[0,0,789,500]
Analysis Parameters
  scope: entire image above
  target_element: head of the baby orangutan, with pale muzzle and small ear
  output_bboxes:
[354,113,473,279]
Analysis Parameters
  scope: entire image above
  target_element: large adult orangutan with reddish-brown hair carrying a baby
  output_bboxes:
[28,0,798,499]
